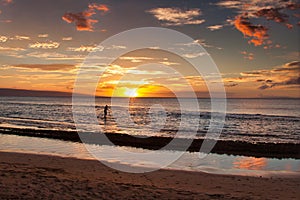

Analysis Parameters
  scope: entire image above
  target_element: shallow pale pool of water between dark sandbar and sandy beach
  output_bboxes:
[0,134,300,176]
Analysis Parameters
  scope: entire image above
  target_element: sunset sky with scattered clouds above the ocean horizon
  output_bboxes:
[0,0,300,98]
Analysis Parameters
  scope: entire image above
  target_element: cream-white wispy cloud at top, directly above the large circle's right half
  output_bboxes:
[147,8,205,26]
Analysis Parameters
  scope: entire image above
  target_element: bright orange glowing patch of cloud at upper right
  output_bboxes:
[234,15,269,46]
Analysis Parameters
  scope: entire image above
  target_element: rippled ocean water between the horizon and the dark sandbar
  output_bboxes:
[0,97,300,143]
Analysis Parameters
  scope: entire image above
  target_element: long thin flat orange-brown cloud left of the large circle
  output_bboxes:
[13,64,75,71]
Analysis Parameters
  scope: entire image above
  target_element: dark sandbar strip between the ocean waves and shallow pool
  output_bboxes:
[0,128,300,159]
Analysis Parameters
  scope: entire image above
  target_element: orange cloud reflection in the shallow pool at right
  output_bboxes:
[233,157,267,170]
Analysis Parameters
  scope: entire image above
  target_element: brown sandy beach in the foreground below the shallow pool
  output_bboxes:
[0,152,300,199]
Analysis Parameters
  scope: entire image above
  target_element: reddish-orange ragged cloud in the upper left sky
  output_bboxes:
[62,3,109,31]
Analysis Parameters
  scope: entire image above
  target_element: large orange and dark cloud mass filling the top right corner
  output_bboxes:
[216,0,300,46]
